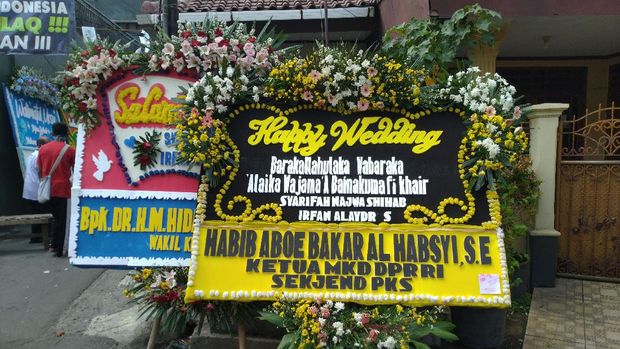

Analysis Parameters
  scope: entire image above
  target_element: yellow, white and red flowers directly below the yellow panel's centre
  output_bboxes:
[261,299,458,349]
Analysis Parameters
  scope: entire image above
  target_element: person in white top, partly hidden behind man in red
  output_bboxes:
[22,137,49,242]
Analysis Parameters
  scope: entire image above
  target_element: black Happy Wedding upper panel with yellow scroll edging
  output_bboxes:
[207,108,489,225]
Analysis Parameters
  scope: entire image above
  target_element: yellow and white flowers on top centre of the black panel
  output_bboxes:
[264,45,425,113]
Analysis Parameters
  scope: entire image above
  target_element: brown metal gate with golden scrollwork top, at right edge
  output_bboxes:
[555,103,620,278]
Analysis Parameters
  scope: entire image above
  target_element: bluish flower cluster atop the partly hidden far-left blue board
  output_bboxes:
[9,66,61,108]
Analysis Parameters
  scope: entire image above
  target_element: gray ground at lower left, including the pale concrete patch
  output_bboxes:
[0,230,148,349]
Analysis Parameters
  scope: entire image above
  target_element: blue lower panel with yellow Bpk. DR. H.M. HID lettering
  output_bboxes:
[73,197,196,265]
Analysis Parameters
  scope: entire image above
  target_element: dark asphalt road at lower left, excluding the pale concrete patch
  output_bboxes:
[0,231,113,349]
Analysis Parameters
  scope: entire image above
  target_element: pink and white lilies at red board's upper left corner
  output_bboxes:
[60,41,131,130]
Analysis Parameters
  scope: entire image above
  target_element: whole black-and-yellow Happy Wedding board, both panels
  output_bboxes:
[186,103,510,306]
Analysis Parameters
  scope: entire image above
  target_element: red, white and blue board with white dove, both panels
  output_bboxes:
[69,71,199,266]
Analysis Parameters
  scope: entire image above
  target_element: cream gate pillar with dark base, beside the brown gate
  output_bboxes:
[528,103,568,287]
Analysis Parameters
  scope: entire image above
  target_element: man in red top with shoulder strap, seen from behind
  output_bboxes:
[37,122,75,257]
